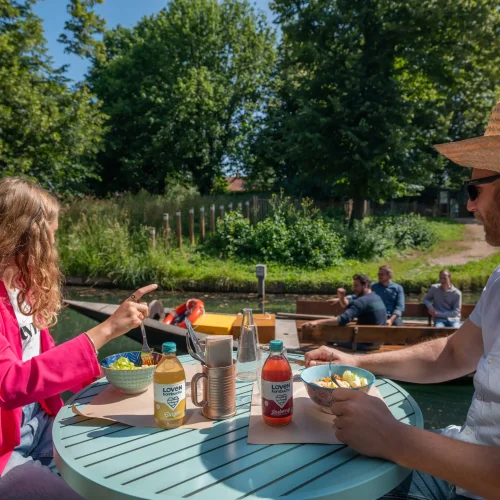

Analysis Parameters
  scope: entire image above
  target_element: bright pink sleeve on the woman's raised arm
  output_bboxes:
[0,334,100,410]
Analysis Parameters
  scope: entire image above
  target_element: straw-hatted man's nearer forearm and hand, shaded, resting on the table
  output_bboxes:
[330,389,500,498]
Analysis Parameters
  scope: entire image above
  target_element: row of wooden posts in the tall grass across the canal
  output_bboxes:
[149,201,252,250]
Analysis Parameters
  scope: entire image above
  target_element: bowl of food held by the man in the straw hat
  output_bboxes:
[300,364,375,413]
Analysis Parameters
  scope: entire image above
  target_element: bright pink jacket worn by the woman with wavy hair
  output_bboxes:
[0,280,100,474]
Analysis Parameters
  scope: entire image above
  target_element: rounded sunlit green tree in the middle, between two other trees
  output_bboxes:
[89,0,275,194]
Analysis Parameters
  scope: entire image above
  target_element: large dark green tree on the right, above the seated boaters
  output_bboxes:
[252,0,500,218]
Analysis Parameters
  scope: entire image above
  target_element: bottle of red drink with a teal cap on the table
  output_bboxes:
[261,340,293,427]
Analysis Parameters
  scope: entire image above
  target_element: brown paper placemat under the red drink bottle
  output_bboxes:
[247,372,384,444]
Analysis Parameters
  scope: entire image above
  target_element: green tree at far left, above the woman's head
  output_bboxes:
[0,0,104,194]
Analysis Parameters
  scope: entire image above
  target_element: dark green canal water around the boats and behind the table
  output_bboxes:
[51,287,479,429]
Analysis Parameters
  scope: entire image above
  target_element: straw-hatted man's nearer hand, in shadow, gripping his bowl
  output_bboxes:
[330,389,406,460]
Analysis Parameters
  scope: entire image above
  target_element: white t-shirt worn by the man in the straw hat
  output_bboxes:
[444,266,500,499]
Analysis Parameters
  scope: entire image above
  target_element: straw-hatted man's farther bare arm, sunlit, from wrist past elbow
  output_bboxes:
[353,320,484,384]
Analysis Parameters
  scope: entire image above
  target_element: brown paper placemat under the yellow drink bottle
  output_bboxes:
[73,365,213,429]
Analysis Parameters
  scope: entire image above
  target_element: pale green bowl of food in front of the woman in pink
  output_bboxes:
[101,351,161,394]
